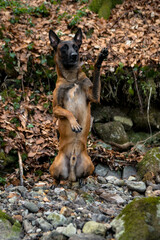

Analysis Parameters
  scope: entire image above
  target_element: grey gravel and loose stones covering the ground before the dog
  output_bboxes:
[0,164,160,240]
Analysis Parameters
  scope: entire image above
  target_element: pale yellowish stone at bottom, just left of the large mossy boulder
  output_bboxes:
[82,221,107,236]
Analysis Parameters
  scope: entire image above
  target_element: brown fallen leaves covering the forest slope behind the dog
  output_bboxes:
[0,0,157,184]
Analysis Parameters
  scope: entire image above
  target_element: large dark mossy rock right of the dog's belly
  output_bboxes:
[94,122,128,144]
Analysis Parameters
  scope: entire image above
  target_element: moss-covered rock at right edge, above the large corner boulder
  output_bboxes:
[137,147,160,180]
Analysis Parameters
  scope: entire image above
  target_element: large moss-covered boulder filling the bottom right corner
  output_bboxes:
[111,197,160,240]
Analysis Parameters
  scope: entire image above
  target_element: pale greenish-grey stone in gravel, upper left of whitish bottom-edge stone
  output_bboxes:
[47,212,67,228]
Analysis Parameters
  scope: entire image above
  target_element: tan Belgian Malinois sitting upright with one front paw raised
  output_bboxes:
[49,29,108,181]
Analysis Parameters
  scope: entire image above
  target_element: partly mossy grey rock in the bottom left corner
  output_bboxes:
[0,210,22,240]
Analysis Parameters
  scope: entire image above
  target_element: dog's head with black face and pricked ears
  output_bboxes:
[49,29,82,69]
